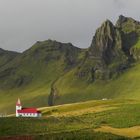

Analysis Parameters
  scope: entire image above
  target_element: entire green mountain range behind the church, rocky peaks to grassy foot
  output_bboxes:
[0,15,140,112]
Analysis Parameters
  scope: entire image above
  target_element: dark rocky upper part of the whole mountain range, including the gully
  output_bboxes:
[0,15,140,105]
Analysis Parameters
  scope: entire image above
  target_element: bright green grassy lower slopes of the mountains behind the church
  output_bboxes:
[0,37,140,114]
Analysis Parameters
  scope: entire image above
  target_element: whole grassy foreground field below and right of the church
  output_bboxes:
[0,100,140,140]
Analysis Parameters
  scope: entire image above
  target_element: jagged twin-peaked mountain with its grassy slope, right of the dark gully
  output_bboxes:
[51,16,140,104]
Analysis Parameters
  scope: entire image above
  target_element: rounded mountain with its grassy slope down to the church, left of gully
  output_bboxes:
[0,40,82,111]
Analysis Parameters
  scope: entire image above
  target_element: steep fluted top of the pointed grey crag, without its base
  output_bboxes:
[89,20,126,64]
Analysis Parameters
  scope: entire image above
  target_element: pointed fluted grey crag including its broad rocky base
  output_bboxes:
[76,20,128,81]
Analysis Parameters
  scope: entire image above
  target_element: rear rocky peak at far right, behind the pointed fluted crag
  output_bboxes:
[116,15,140,60]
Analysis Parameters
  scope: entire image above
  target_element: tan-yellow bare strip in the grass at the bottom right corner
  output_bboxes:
[94,126,140,138]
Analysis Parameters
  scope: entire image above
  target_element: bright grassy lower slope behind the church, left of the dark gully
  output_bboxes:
[0,60,61,113]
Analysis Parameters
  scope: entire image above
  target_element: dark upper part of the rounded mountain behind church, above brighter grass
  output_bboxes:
[0,40,81,89]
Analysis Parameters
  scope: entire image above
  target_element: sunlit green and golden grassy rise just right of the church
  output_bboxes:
[42,100,140,128]
